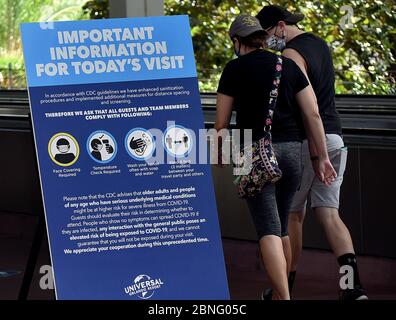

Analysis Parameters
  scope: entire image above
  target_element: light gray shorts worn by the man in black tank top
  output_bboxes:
[291,134,348,212]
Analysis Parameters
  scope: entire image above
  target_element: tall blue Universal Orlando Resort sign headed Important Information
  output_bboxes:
[21,16,229,299]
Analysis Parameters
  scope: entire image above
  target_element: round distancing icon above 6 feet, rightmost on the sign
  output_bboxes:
[164,126,193,158]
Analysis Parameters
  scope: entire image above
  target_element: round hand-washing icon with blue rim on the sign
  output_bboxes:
[125,128,155,160]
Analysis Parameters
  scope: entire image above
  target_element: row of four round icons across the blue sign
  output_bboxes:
[48,126,192,167]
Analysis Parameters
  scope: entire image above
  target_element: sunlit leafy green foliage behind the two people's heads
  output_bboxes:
[165,0,396,94]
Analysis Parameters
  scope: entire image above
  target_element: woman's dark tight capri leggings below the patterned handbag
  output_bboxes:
[247,142,302,239]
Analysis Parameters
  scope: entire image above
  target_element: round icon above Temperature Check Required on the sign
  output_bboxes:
[87,130,117,163]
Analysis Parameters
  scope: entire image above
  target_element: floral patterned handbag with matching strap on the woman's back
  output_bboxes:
[234,56,282,198]
